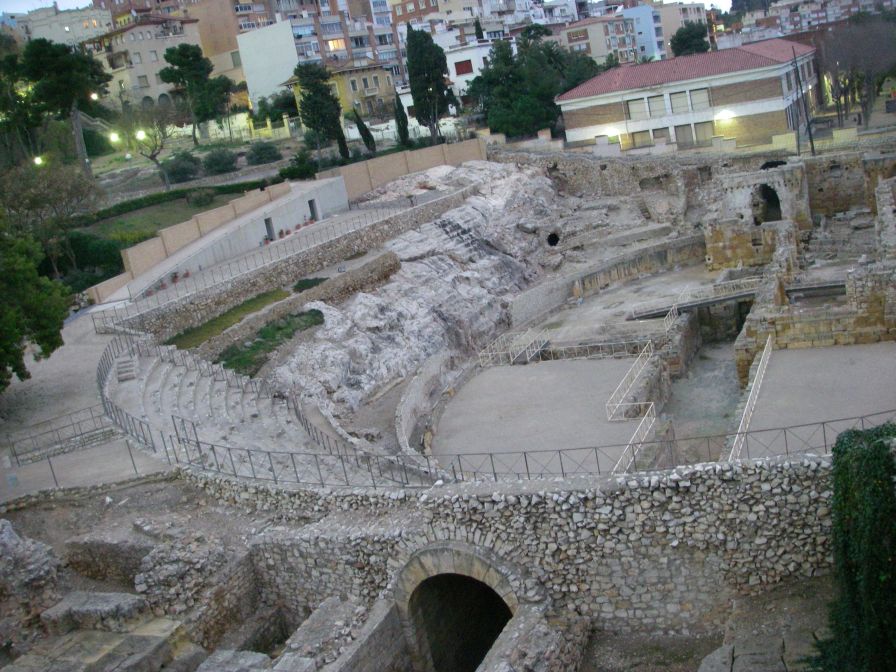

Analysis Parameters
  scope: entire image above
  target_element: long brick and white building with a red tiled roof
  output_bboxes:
[557,39,817,149]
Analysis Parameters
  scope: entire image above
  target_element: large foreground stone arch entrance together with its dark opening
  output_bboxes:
[391,541,547,672]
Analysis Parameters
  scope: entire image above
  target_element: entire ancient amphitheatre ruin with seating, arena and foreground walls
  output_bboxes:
[0,140,896,672]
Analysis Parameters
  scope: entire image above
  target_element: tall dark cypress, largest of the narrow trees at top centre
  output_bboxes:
[407,24,454,142]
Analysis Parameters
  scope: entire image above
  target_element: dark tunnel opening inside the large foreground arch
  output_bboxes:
[409,574,512,672]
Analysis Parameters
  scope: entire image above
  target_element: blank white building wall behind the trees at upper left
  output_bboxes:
[236,21,299,107]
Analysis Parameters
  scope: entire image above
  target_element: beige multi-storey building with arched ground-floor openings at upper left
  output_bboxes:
[83,10,199,108]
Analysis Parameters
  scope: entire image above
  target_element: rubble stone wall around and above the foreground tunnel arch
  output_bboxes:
[187,456,831,632]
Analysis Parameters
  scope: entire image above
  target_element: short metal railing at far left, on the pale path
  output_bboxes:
[6,404,115,466]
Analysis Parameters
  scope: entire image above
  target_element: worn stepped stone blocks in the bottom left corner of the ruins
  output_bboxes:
[2,592,207,672]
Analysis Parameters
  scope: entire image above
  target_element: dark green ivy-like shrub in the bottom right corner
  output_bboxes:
[813,423,896,672]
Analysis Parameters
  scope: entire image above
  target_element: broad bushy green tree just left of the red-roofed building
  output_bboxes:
[468,31,604,137]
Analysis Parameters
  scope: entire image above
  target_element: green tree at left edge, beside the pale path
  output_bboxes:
[0,216,68,392]
